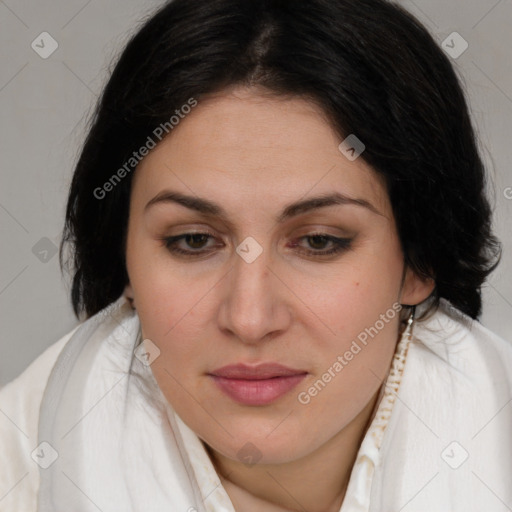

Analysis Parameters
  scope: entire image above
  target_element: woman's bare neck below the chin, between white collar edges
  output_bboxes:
[206,390,380,512]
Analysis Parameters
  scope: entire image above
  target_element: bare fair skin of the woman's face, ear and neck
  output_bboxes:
[126,88,434,512]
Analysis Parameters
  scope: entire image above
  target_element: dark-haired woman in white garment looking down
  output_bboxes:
[0,0,512,512]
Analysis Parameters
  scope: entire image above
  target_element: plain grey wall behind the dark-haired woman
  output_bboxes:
[0,0,512,386]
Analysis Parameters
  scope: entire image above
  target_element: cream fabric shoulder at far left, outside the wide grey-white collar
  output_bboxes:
[0,326,78,512]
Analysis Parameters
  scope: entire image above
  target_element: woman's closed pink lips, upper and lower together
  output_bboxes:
[209,363,307,405]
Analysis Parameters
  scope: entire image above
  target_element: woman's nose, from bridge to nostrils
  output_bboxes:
[218,246,291,345]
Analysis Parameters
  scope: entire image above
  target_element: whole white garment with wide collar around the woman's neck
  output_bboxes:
[0,297,512,512]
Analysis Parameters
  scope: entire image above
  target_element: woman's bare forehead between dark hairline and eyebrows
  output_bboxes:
[133,88,390,218]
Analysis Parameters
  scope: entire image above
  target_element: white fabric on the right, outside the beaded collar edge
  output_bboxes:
[373,300,512,512]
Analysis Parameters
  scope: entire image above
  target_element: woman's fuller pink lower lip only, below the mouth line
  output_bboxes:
[211,373,306,405]
